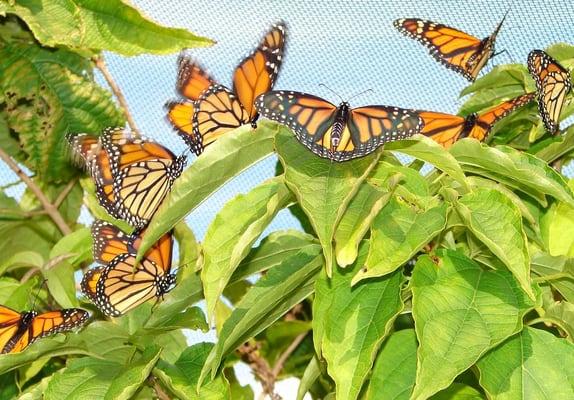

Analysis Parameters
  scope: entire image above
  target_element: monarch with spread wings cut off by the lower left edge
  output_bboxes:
[0,305,90,354]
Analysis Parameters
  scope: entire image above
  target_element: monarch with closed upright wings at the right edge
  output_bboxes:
[528,50,572,135]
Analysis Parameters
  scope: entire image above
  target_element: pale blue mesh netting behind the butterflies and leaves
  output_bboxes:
[0,0,574,396]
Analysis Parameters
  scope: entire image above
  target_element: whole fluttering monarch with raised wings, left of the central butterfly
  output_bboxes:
[166,22,287,155]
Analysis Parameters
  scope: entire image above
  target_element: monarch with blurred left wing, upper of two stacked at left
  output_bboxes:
[67,128,186,228]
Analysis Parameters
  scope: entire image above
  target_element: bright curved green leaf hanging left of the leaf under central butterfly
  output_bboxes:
[201,178,291,322]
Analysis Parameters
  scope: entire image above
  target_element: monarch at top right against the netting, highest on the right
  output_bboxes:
[394,12,508,82]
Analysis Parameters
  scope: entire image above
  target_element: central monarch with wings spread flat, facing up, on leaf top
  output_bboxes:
[255,91,422,161]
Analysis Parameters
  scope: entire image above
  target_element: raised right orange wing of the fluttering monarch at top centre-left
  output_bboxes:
[233,22,287,121]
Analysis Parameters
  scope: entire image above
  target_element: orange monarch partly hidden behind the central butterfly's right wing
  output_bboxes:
[419,93,534,148]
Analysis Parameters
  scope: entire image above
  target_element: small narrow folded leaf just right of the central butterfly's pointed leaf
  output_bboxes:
[334,182,392,267]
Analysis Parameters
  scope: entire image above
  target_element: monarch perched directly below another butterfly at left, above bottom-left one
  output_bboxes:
[81,220,175,317]
